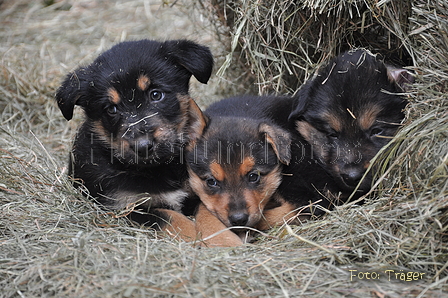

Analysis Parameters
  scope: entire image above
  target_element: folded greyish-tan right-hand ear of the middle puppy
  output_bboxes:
[258,123,291,165]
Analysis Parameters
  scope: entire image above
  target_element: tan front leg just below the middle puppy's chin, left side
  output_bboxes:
[196,203,243,247]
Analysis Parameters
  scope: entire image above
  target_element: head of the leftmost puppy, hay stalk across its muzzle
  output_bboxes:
[56,40,213,165]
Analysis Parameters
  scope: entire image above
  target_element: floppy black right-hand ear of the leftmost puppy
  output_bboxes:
[166,40,213,84]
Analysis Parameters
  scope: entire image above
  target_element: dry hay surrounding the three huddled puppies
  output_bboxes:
[0,0,448,297]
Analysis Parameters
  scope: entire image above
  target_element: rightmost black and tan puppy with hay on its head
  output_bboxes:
[213,49,413,228]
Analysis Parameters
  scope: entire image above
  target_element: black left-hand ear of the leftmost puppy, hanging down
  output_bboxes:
[55,71,87,120]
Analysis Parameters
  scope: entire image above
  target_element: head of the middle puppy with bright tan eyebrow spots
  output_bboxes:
[187,117,291,227]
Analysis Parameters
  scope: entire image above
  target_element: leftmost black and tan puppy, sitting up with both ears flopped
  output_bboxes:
[56,40,213,239]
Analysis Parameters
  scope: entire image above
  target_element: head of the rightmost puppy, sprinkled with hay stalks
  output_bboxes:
[290,50,413,191]
